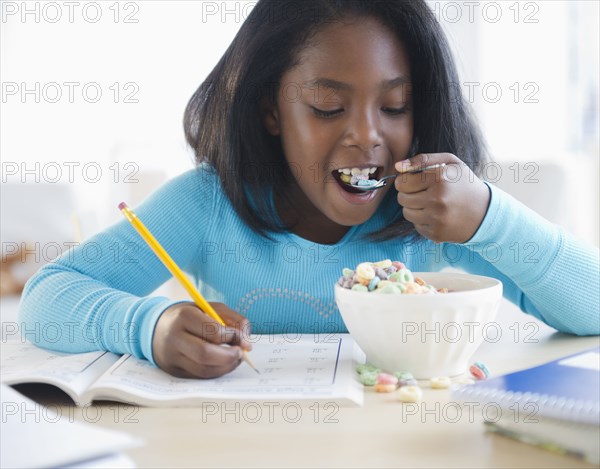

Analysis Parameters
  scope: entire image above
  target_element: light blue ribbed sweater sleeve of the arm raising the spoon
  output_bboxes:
[452,181,600,335]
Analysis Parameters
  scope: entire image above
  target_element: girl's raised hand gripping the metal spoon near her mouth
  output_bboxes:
[395,153,490,243]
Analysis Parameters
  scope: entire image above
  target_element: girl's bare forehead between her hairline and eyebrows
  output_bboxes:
[289,17,410,82]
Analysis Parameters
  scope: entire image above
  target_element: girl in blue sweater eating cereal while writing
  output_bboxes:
[21,0,600,377]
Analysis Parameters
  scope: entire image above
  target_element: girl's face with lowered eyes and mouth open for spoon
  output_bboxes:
[265,18,413,240]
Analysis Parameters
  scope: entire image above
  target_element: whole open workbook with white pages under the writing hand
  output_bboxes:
[0,334,364,407]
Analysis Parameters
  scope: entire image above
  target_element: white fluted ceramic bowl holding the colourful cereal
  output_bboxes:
[335,272,502,379]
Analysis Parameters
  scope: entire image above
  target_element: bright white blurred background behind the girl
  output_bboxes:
[0,0,600,268]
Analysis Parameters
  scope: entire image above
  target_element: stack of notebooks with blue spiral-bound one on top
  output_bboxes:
[452,347,600,464]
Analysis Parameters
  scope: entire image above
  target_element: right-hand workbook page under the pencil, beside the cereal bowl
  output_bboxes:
[90,334,356,402]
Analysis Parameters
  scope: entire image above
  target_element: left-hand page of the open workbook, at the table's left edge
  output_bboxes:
[0,340,119,404]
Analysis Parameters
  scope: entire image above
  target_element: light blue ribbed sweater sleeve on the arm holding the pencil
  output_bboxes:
[19,168,219,363]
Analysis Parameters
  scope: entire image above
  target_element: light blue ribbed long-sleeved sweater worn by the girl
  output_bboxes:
[20,166,600,362]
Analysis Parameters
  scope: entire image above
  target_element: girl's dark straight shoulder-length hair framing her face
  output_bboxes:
[184,0,485,240]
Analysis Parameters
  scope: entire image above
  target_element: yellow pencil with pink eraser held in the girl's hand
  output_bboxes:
[119,202,260,374]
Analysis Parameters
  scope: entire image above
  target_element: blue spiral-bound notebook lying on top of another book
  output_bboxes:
[453,347,600,425]
